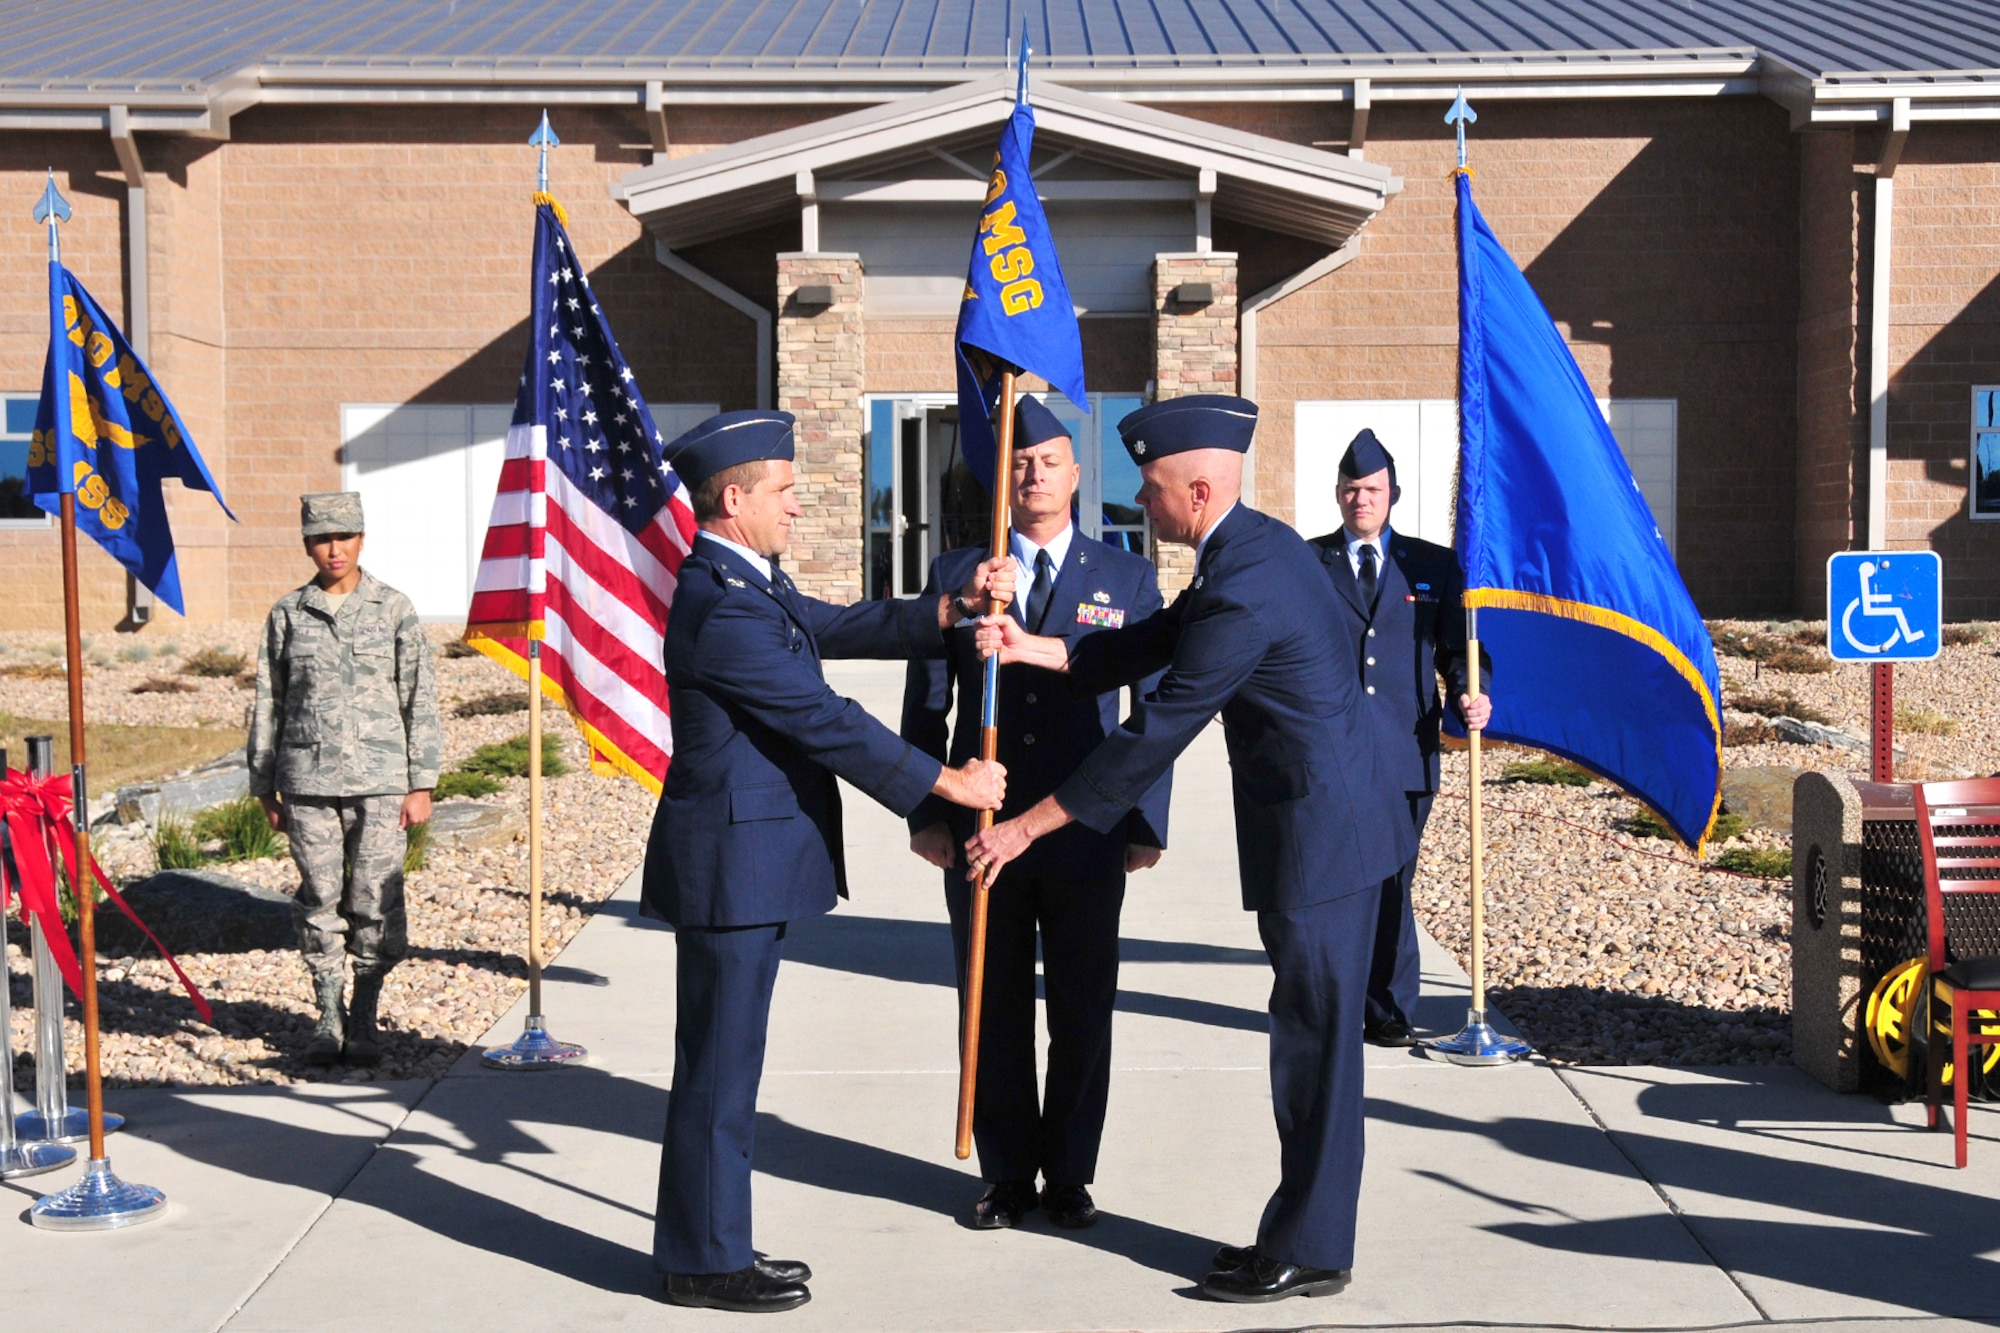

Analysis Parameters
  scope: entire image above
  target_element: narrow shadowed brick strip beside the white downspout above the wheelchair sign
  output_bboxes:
[1792,130,1868,614]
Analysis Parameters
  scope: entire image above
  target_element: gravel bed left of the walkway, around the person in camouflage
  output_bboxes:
[0,626,654,1088]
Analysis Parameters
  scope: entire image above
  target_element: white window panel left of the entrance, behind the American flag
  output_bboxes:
[340,402,716,620]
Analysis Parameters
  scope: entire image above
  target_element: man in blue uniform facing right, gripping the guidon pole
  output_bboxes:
[644,412,1014,1311]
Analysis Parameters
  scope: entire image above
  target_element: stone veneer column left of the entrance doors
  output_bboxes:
[778,254,866,602]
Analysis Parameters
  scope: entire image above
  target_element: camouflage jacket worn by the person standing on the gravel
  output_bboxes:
[250,572,442,797]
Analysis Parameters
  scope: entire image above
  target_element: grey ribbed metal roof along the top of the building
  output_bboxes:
[0,0,2000,92]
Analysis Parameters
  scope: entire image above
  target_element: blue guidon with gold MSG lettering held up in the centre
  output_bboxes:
[958,44,1090,490]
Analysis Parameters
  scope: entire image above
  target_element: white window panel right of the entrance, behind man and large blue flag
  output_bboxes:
[1292,398,1680,550]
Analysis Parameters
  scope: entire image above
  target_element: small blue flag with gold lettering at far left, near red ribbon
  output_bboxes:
[28,262,236,614]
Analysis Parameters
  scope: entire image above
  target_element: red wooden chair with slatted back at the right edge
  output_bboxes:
[1914,777,2000,1167]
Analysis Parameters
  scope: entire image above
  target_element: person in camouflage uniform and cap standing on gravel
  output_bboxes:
[250,490,442,1065]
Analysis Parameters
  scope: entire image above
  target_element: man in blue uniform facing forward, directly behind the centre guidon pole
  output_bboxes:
[902,398,1170,1229]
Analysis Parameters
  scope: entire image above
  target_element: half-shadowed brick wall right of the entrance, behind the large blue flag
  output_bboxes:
[1258,98,1798,614]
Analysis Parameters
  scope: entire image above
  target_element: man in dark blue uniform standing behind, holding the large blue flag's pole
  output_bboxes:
[1312,430,1492,1047]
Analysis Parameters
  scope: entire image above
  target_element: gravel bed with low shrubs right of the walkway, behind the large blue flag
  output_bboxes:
[1414,622,2000,1065]
